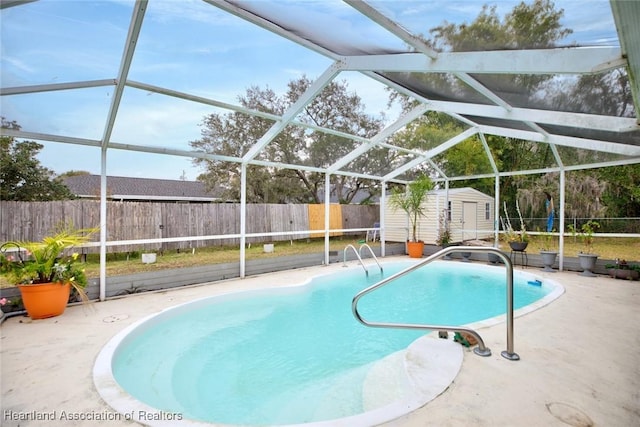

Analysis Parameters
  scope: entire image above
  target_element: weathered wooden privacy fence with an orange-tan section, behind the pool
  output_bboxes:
[0,200,379,252]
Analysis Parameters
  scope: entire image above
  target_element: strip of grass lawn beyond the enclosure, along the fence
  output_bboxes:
[0,236,640,287]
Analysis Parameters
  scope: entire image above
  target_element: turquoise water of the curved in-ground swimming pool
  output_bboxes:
[94,262,564,425]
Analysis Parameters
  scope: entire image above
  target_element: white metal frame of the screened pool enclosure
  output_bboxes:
[0,0,640,299]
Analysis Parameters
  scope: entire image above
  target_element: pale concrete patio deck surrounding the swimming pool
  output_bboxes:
[0,258,640,427]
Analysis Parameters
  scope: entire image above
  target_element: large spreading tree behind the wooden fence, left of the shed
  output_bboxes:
[190,77,389,203]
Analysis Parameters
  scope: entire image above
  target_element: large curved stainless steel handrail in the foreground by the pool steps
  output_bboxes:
[351,246,520,360]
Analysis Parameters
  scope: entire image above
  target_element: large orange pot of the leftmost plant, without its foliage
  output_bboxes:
[18,283,71,319]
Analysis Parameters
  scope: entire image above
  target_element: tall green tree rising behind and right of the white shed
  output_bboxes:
[390,0,572,205]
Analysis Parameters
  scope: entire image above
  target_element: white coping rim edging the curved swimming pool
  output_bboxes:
[93,260,564,427]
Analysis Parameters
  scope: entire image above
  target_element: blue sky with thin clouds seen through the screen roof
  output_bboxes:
[0,0,618,180]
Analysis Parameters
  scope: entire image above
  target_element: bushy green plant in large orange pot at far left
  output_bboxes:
[0,224,96,319]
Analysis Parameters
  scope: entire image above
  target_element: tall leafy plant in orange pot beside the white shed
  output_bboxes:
[389,175,433,258]
